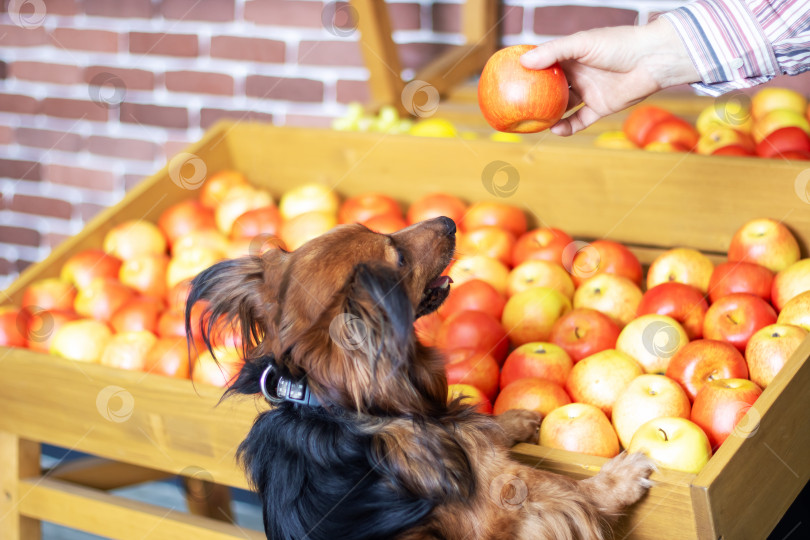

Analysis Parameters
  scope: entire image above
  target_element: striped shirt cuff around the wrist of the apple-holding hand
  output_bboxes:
[661,0,781,95]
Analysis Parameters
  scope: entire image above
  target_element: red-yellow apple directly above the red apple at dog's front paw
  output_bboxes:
[501,341,574,388]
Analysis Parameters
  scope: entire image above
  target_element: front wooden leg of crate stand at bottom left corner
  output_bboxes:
[0,431,40,540]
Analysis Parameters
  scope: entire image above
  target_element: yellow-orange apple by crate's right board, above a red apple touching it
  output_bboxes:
[745,324,808,388]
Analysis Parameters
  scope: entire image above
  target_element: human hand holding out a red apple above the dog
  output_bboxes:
[520,19,700,136]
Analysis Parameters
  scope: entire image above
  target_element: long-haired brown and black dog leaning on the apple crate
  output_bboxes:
[186,218,652,540]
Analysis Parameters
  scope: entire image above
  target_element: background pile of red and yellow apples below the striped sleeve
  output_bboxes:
[595,88,810,160]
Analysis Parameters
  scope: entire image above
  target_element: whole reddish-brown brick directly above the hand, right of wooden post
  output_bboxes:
[534,6,638,36]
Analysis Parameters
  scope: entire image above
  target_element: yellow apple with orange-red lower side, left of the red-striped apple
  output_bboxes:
[501,287,571,346]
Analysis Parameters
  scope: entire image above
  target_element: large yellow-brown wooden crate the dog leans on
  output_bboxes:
[0,122,810,540]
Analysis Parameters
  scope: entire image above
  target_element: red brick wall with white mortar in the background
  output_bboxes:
[0,0,784,285]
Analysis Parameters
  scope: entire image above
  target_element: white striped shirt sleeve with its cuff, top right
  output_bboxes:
[661,0,810,96]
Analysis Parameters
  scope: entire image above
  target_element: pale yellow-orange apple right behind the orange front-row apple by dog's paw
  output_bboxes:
[565,349,644,417]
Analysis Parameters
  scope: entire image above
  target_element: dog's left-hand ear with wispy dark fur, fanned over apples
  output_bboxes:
[186,249,288,358]
